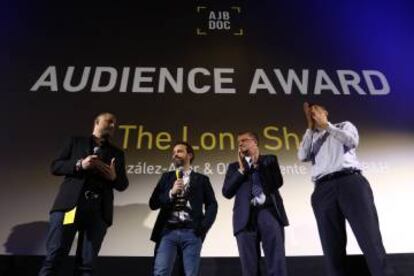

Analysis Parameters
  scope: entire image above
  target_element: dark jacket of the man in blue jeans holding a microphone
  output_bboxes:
[149,171,217,242]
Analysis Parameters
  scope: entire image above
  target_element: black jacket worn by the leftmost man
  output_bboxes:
[50,136,129,225]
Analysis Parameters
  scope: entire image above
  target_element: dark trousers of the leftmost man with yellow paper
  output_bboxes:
[39,199,108,276]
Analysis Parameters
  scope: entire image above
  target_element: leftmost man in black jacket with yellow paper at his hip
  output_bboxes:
[39,113,128,276]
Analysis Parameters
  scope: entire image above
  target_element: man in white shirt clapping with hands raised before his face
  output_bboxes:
[298,103,395,276]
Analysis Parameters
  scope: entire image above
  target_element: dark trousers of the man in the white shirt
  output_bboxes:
[311,173,395,276]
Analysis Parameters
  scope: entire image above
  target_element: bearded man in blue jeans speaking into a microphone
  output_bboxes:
[149,142,217,276]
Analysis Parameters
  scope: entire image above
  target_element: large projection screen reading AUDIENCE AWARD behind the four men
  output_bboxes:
[0,0,414,256]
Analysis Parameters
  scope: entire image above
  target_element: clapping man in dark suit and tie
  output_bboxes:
[223,131,289,276]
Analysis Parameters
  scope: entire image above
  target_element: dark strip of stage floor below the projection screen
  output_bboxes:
[0,254,414,276]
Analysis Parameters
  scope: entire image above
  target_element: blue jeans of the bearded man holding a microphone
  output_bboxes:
[154,228,202,276]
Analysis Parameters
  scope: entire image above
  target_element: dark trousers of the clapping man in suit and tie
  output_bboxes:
[236,208,287,276]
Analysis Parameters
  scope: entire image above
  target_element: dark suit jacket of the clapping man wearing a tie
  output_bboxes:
[222,155,289,235]
